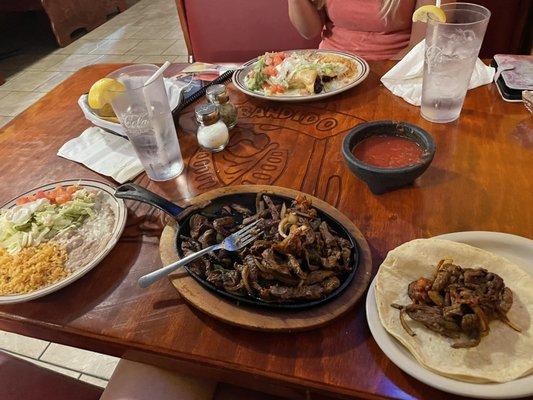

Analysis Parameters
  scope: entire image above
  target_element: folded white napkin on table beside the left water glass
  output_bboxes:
[57,126,144,183]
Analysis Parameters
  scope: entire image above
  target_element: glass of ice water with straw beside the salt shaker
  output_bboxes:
[108,64,183,181]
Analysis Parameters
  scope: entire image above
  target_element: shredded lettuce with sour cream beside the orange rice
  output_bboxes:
[0,189,96,254]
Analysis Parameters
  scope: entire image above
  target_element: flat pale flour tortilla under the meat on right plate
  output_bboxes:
[376,239,533,383]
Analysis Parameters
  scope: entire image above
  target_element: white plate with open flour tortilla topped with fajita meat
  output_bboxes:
[366,232,533,399]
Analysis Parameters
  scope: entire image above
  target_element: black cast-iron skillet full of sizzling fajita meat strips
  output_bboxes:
[115,183,369,309]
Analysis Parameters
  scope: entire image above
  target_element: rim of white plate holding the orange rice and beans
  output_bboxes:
[0,179,127,304]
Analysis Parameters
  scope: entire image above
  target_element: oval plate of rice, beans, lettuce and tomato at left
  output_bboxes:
[0,180,127,304]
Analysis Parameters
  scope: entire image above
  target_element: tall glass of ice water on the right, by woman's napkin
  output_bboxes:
[421,3,490,123]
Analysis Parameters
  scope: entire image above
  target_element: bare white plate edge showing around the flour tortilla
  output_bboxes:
[366,232,533,399]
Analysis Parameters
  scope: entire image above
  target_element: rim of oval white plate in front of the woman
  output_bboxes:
[232,50,370,102]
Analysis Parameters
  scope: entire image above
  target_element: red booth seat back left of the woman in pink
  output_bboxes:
[176,0,320,63]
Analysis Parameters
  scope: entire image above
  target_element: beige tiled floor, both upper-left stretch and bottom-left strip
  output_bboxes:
[0,0,187,387]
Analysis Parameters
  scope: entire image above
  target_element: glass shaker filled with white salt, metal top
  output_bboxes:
[194,103,229,153]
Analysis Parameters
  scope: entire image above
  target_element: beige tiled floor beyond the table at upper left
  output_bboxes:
[0,0,187,127]
